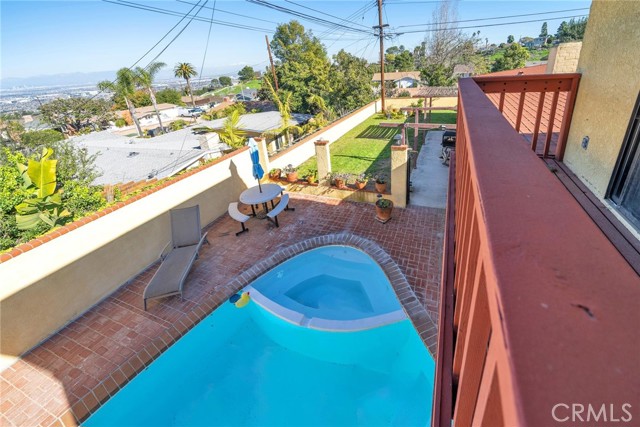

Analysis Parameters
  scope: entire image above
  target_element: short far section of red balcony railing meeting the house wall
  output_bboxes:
[473,74,580,160]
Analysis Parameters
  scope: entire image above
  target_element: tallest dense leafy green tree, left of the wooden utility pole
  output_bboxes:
[267,21,331,113]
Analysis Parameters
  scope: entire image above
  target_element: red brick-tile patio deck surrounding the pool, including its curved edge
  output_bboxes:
[0,195,444,426]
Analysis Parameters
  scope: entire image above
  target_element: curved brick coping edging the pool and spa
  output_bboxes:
[69,232,438,426]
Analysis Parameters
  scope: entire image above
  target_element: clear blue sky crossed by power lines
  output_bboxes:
[0,0,591,78]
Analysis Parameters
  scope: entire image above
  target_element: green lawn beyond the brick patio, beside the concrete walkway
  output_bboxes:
[298,111,456,182]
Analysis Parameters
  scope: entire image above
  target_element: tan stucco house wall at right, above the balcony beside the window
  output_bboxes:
[564,0,640,197]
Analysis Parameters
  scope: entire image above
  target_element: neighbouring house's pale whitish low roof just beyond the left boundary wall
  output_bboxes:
[71,123,229,185]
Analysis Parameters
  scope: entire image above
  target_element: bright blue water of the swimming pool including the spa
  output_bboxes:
[83,246,434,427]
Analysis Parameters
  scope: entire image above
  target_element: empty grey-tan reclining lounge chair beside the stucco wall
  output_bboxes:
[143,205,209,311]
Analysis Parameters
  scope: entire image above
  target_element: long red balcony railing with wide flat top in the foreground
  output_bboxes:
[432,79,640,427]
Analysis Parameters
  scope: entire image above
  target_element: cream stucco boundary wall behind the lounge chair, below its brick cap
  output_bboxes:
[0,150,255,359]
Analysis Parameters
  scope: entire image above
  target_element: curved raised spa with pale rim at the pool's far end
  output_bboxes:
[247,246,406,331]
